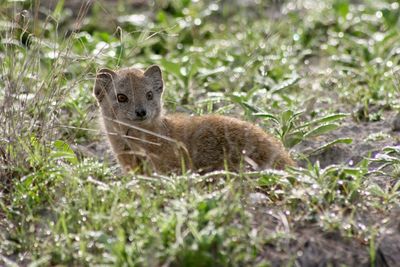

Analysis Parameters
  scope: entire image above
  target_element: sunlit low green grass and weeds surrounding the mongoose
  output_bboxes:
[0,0,400,266]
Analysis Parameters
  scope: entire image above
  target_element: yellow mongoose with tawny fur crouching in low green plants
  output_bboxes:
[94,65,294,173]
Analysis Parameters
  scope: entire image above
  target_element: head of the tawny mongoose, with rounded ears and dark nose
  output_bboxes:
[94,65,164,124]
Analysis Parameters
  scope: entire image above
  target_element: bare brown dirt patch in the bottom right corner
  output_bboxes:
[249,196,400,267]
